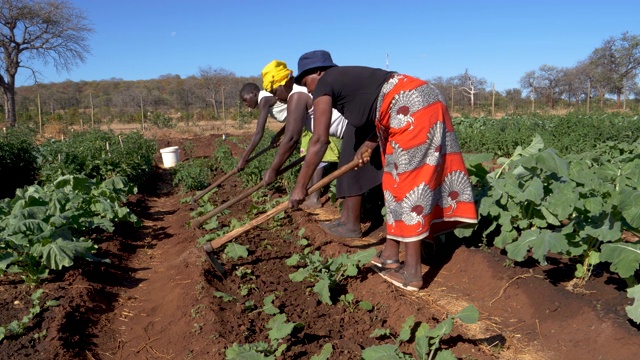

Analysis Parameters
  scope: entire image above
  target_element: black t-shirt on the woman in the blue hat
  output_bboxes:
[313,66,393,128]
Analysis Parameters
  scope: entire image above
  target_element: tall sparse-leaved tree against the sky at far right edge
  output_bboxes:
[588,32,640,107]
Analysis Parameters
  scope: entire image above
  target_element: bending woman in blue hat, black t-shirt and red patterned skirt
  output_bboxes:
[290,50,477,291]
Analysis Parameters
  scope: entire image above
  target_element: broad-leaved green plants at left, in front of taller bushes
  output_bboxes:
[0,176,140,283]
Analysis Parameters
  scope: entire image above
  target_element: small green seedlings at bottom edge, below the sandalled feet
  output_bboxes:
[362,305,479,360]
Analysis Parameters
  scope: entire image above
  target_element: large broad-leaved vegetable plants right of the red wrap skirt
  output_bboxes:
[456,136,640,323]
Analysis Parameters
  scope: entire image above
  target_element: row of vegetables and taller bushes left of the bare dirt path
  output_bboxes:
[0,130,156,283]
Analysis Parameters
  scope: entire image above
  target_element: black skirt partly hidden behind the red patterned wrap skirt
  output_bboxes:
[336,122,382,198]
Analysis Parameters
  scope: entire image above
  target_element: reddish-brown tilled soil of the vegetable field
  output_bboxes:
[0,131,640,360]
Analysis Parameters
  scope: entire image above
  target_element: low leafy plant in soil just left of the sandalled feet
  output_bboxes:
[286,248,375,305]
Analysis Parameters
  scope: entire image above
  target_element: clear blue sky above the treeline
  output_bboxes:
[17,0,640,90]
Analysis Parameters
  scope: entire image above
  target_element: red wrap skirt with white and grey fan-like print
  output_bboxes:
[376,75,477,241]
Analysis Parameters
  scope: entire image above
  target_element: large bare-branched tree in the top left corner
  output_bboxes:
[0,0,94,126]
